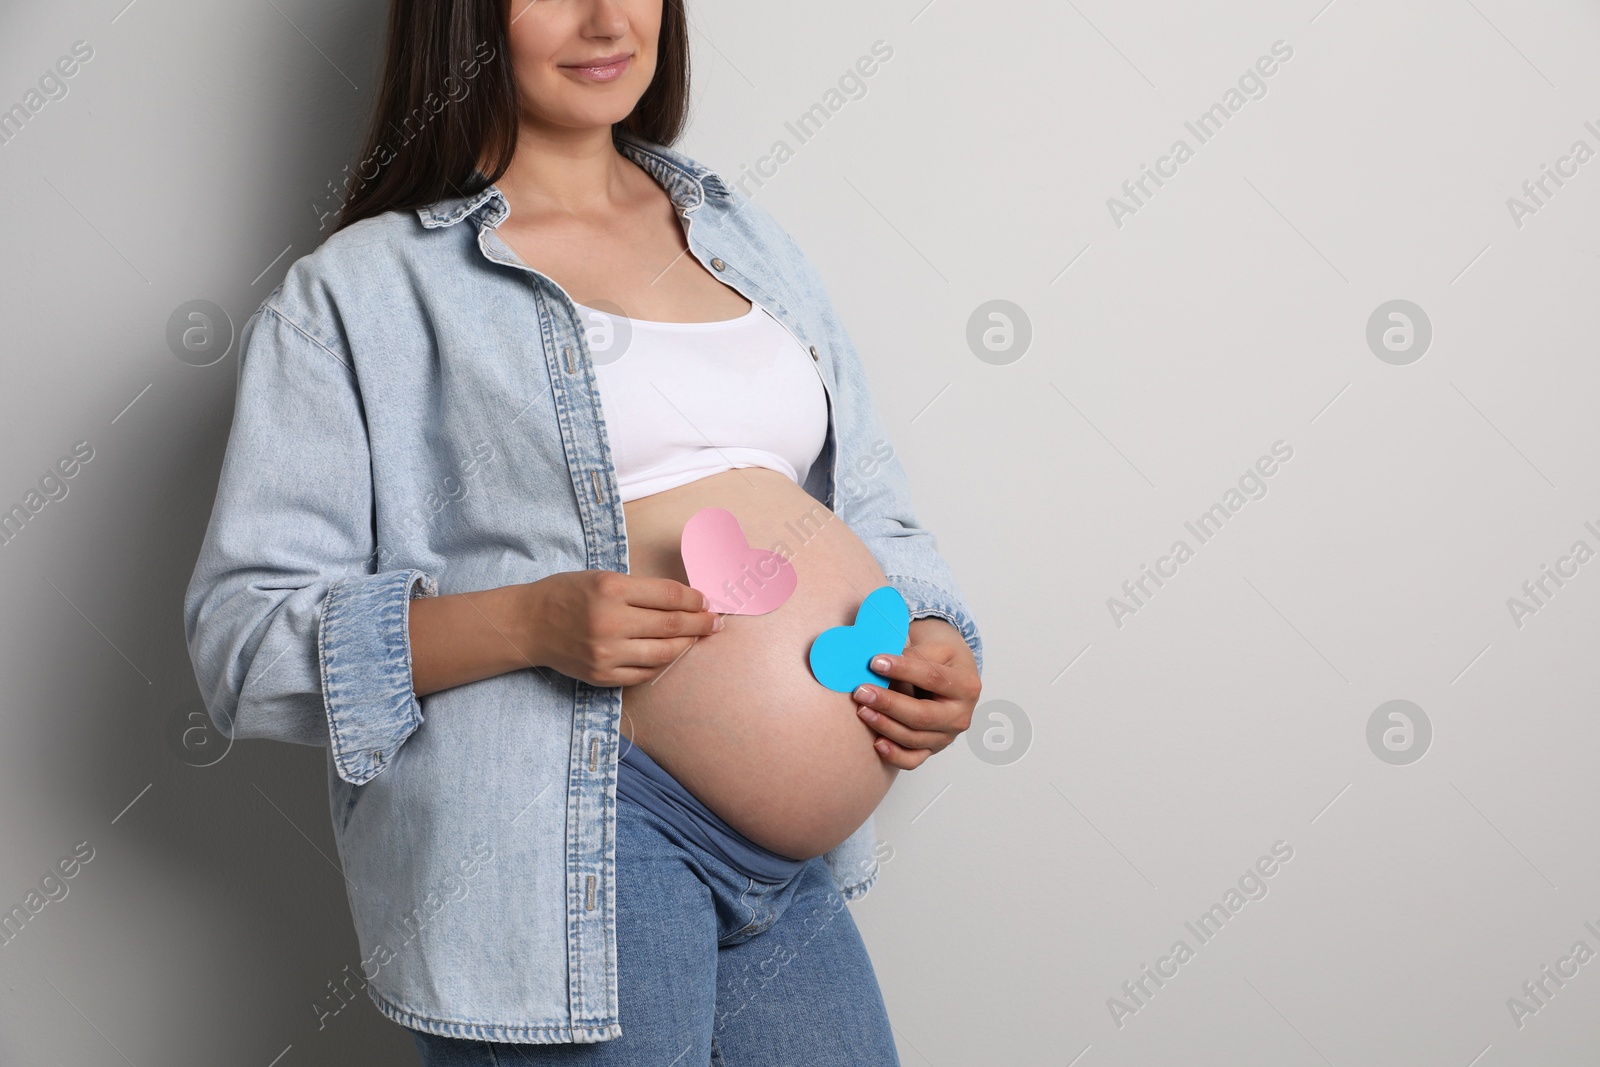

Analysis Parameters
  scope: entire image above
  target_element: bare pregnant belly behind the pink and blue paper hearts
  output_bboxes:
[622,467,896,859]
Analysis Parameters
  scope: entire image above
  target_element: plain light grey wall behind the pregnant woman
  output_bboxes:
[0,0,1600,1067]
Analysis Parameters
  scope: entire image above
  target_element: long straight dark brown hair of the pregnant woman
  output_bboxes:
[323,0,690,232]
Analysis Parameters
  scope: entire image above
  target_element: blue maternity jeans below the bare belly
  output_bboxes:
[411,783,899,1067]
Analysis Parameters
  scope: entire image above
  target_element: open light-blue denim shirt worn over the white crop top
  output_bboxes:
[184,130,982,1043]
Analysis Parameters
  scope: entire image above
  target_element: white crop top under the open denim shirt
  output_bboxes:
[574,301,827,504]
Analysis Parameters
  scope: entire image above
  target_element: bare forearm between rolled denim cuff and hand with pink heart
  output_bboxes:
[408,585,538,696]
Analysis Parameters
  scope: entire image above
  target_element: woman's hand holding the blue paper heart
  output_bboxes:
[851,617,982,771]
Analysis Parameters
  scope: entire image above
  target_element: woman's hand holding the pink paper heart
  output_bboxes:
[523,571,723,686]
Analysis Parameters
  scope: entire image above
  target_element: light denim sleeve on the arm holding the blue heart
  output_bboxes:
[786,235,984,673]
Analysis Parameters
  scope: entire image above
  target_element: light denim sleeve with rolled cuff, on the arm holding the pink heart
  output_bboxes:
[184,302,438,785]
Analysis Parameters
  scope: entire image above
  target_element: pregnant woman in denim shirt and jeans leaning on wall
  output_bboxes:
[184,0,982,1067]
